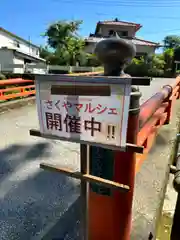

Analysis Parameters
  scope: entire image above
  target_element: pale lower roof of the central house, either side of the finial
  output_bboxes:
[85,37,159,47]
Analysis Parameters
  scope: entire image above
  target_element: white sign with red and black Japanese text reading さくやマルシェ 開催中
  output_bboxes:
[36,81,131,147]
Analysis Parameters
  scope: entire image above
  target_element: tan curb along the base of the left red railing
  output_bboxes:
[0,96,36,113]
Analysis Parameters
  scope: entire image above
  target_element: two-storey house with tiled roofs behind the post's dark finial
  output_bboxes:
[85,18,160,57]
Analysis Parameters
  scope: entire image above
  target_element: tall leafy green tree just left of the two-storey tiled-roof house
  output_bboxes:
[42,20,84,65]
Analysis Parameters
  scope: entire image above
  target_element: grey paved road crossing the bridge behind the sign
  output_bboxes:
[0,79,177,240]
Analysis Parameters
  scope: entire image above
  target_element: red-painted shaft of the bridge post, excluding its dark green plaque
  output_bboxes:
[89,89,140,240]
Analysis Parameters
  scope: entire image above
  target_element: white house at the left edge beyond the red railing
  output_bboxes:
[0,27,45,73]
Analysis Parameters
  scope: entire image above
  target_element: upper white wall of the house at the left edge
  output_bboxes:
[0,30,39,57]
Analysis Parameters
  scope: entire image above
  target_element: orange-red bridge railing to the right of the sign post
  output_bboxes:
[136,77,180,172]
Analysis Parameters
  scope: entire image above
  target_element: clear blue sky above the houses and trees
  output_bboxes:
[0,0,180,44]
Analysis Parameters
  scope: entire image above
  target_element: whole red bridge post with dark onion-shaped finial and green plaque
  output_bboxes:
[88,40,140,240]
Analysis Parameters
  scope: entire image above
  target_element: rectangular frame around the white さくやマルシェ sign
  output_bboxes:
[35,74,150,151]
